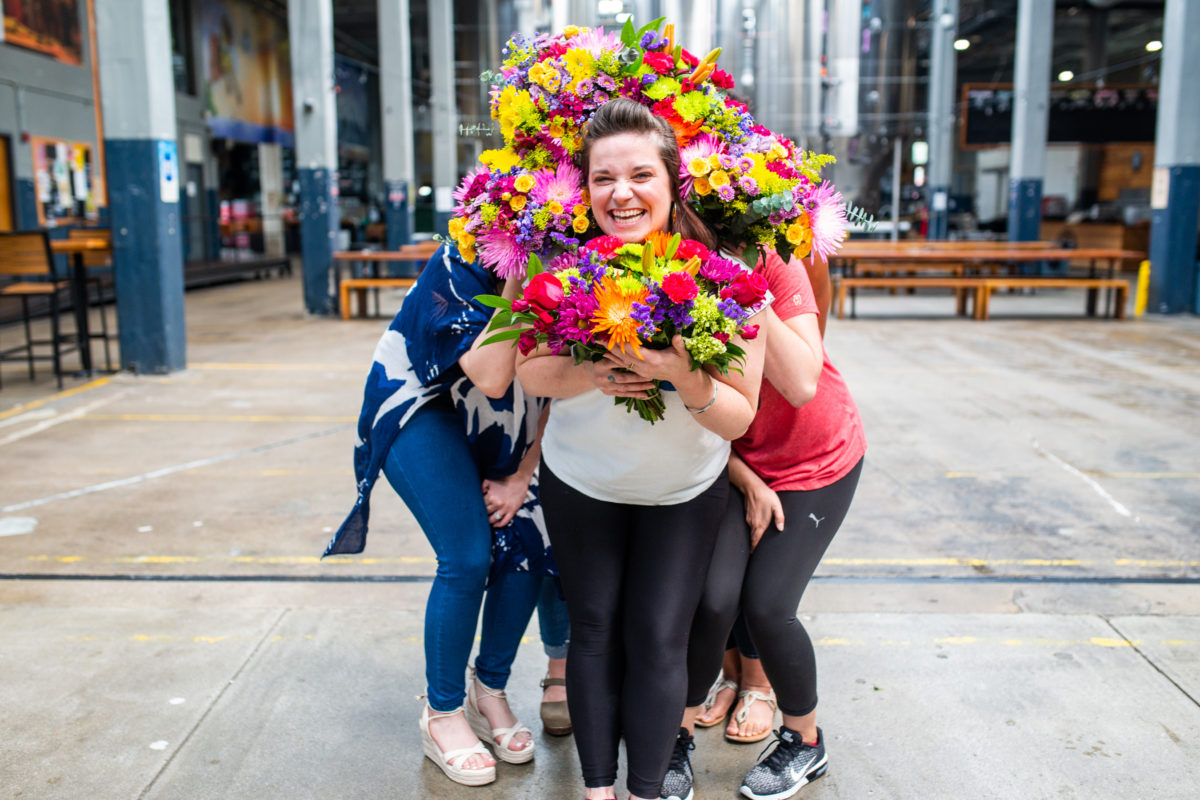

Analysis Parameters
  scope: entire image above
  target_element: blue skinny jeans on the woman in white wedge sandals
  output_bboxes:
[384,401,542,711]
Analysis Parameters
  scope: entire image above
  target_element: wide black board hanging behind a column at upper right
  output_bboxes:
[961,84,1158,148]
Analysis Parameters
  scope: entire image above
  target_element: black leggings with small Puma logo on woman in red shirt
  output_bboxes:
[688,461,863,716]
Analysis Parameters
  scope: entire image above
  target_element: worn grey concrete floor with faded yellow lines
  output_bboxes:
[0,272,1200,800]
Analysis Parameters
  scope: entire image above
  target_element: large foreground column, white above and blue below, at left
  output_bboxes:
[96,0,187,374]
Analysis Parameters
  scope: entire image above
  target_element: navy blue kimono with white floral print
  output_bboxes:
[325,246,557,581]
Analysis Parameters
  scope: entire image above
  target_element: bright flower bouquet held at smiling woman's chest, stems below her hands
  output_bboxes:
[476,234,767,423]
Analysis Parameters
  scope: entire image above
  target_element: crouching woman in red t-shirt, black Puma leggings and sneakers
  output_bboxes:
[662,253,866,800]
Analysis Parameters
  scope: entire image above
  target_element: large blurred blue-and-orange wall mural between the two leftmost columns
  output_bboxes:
[200,0,294,148]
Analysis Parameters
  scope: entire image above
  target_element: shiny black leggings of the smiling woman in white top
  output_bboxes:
[541,462,730,798]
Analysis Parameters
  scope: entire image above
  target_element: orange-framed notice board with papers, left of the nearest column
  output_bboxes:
[29,137,96,225]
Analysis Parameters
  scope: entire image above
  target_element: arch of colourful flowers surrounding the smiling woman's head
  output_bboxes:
[450,19,846,278]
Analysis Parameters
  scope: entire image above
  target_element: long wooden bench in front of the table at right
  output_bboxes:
[834,275,1129,320]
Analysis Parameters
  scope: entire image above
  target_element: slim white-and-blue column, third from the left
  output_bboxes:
[379,0,415,255]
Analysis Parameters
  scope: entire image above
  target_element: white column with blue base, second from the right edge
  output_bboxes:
[1008,0,1054,241]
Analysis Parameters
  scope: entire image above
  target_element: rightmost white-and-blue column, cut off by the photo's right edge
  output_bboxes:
[1148,0,1200,314]
